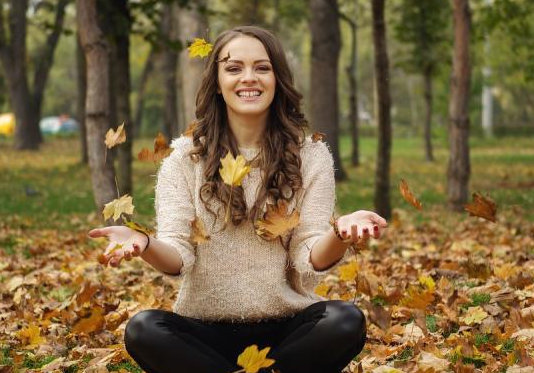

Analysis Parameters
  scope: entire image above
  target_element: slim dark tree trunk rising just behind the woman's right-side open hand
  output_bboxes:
[372,0,391,219]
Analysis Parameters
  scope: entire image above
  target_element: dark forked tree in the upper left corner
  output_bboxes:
[0,0,69,150]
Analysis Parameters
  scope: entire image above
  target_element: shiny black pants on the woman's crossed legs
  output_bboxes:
[124,300,366,373]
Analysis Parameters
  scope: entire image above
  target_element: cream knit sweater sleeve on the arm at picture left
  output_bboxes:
[155,136,196,278]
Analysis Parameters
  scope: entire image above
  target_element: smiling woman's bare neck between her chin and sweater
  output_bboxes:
[228,111,268,149]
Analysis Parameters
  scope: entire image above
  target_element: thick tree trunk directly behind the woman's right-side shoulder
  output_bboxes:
[309,0,347,181]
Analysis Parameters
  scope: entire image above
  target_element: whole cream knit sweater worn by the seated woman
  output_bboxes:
[155,136,351,322]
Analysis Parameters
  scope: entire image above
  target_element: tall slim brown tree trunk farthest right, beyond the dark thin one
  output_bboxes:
[447,0,471,211]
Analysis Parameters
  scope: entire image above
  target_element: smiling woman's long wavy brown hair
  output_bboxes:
[188,26,308,230]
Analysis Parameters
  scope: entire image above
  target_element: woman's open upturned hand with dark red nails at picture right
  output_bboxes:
[337,210,388,243]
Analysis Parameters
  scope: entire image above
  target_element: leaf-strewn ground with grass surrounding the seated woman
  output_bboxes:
[0,139,534,373]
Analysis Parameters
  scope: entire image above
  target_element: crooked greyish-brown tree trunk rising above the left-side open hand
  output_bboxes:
[76,0,116,219]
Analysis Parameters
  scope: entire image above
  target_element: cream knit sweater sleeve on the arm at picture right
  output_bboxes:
[289,141,350,283]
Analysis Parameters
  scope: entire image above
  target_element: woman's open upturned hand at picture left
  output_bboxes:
[89,225,148,267]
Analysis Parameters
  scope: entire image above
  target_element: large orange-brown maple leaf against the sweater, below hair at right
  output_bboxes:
[255,199,300,241]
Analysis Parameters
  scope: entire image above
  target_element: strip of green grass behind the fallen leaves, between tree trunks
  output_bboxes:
[0,136,534,228]
